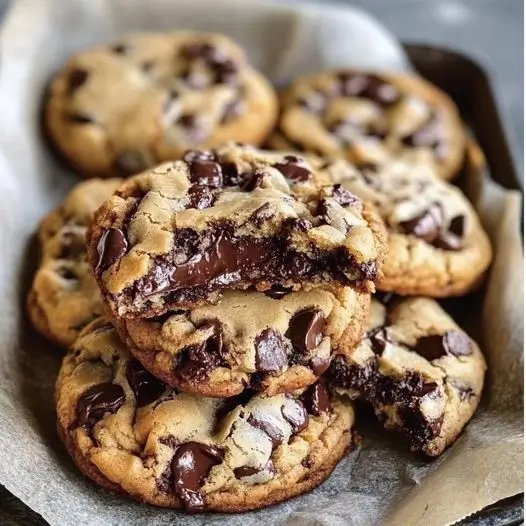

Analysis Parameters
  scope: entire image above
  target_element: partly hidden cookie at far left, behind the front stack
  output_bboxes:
[27,179,122,347]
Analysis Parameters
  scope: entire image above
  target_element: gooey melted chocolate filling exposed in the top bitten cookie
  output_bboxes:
[114,226,377,315]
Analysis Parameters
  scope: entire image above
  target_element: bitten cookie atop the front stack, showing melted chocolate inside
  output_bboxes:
[87,145,385,318]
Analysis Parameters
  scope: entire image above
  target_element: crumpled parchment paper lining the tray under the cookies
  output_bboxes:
[0,0,523,526]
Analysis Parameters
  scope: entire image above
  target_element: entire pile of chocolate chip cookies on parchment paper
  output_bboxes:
[28,32,491,511]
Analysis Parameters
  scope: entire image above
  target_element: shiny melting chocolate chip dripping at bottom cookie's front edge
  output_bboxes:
[171,442,223,512]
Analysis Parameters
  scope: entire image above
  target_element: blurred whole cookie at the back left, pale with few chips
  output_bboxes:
[46,31,278,177]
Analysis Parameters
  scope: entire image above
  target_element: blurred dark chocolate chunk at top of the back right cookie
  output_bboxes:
[339,71,400,106]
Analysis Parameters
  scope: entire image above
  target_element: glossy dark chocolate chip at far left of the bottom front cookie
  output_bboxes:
[77,382,126,427]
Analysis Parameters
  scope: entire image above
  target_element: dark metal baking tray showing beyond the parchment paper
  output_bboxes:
[0,44,524,526]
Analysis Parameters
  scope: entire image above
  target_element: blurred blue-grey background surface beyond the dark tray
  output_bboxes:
[0,0,524,526]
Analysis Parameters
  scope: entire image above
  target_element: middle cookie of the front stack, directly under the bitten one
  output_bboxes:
[112,287,370,396]
